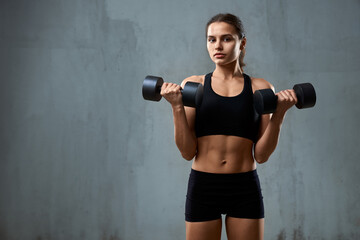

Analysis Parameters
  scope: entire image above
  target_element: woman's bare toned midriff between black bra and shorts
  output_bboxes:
[192,135,256,173]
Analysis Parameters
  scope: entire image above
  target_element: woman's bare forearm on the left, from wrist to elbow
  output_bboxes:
[172,105,197,160]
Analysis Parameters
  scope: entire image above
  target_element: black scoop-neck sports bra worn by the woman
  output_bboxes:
[195,73,260,142]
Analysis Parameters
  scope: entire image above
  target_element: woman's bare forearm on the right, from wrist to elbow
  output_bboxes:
[254,113,285,163]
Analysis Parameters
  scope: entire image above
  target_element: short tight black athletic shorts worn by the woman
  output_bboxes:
[185,169,264,222]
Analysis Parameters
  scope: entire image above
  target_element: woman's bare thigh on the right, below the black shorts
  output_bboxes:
[225,217,264,240]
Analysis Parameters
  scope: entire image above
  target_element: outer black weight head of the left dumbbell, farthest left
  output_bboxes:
[142,75,164,102]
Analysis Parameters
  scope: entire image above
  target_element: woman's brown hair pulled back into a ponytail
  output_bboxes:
[205,13,246,71]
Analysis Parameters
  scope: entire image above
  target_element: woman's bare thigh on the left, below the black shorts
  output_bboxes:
[185,218,222,240]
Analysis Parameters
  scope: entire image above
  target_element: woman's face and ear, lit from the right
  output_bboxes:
[207,22,246,65]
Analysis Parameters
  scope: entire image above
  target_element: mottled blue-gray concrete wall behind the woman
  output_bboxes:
[0,0,360,240]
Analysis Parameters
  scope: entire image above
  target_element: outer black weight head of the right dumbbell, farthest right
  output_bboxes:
[293,83,316,109]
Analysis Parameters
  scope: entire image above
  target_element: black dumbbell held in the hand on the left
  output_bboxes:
[142,75,203,107]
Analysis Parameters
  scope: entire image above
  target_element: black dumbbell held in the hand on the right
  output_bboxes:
[254,83,316,114]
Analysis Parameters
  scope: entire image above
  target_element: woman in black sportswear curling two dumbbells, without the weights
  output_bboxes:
[161,14,297,240]
